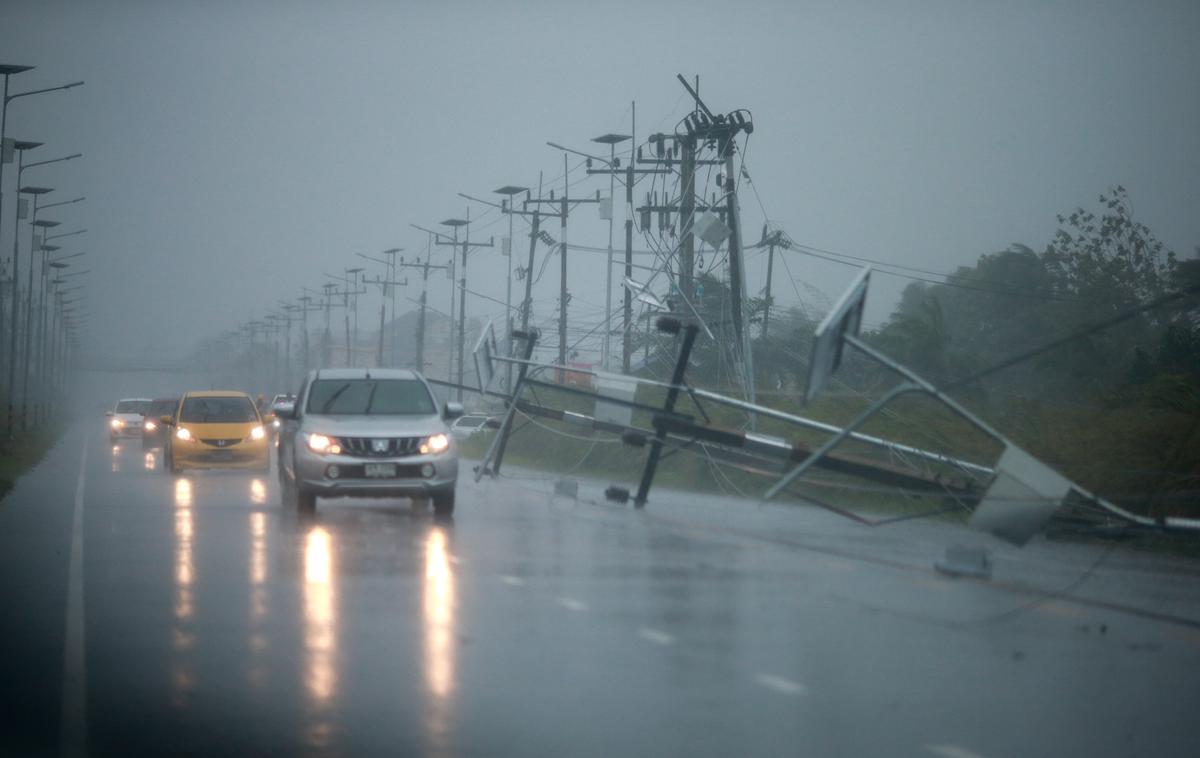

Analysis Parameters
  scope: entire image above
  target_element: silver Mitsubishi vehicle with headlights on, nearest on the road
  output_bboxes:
[276,368,462,516]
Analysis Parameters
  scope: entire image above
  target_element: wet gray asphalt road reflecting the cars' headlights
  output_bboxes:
[0,423,1200,758]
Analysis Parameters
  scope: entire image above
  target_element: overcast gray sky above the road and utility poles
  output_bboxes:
[0,0,1200,364]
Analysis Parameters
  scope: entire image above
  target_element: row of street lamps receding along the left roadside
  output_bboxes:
[0,64,88,437]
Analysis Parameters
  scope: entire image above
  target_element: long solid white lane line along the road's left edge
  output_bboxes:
[59,440,88,756]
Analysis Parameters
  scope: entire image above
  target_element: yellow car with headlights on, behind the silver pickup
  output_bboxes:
[160,392,271,474]
